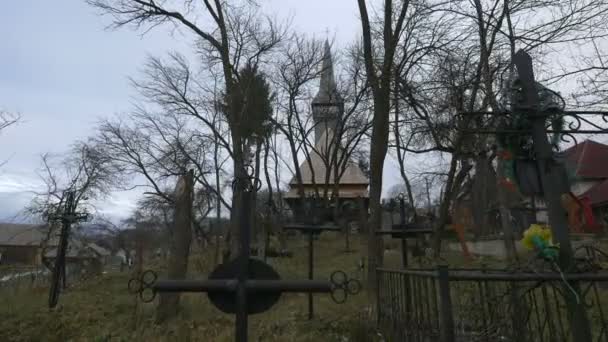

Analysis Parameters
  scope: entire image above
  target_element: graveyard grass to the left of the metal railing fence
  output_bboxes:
[0,233,384,342]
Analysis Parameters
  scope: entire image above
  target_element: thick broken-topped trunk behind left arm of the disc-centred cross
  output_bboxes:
[156,171,194,323]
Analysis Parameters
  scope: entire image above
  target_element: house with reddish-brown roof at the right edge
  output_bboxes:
[563,140,608,227]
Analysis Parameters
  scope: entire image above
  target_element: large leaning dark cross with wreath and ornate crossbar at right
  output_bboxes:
[452,50,608,341]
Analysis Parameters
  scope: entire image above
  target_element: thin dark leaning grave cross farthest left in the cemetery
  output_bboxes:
[48,191,88,309]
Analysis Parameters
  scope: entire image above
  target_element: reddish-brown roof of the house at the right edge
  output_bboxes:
[563,140,608,179]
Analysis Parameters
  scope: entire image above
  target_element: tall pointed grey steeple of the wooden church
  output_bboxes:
[312,40,344,145]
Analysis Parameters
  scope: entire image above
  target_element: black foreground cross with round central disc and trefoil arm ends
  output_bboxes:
[128,175,354,342]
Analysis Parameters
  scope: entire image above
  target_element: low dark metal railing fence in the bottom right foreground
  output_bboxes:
[377,266,608,342]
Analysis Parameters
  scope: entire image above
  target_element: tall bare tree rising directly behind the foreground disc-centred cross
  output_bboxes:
[89,0,284,256]
